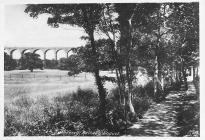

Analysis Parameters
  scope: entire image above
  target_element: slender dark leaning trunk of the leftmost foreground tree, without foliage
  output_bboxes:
[89,30,106,127]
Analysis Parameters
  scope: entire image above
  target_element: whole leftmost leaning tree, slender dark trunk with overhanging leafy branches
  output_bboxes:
[25,4,106,127]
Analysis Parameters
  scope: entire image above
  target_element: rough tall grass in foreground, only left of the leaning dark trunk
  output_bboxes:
[4,90,103,136]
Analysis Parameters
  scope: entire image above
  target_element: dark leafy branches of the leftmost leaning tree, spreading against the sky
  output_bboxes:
[25,4,102,32]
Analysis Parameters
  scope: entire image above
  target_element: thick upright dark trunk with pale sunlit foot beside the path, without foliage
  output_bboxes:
[116,4,136,115]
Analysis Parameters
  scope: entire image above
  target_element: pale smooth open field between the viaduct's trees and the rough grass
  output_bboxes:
[4,70,117,103]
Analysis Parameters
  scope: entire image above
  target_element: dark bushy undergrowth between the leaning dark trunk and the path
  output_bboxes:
[107,88,152,135]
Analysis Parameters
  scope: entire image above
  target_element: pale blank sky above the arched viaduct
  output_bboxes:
[4,4,85,47]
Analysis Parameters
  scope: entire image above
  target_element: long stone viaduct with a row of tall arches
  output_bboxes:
[4,47,72,60]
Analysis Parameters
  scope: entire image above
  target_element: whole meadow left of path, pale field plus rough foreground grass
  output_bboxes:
[4,70,152,136]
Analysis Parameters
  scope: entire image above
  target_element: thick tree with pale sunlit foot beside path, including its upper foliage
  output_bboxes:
[115,3,161,114]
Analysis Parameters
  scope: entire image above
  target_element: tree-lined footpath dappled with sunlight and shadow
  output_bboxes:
[128,83,199,136]
